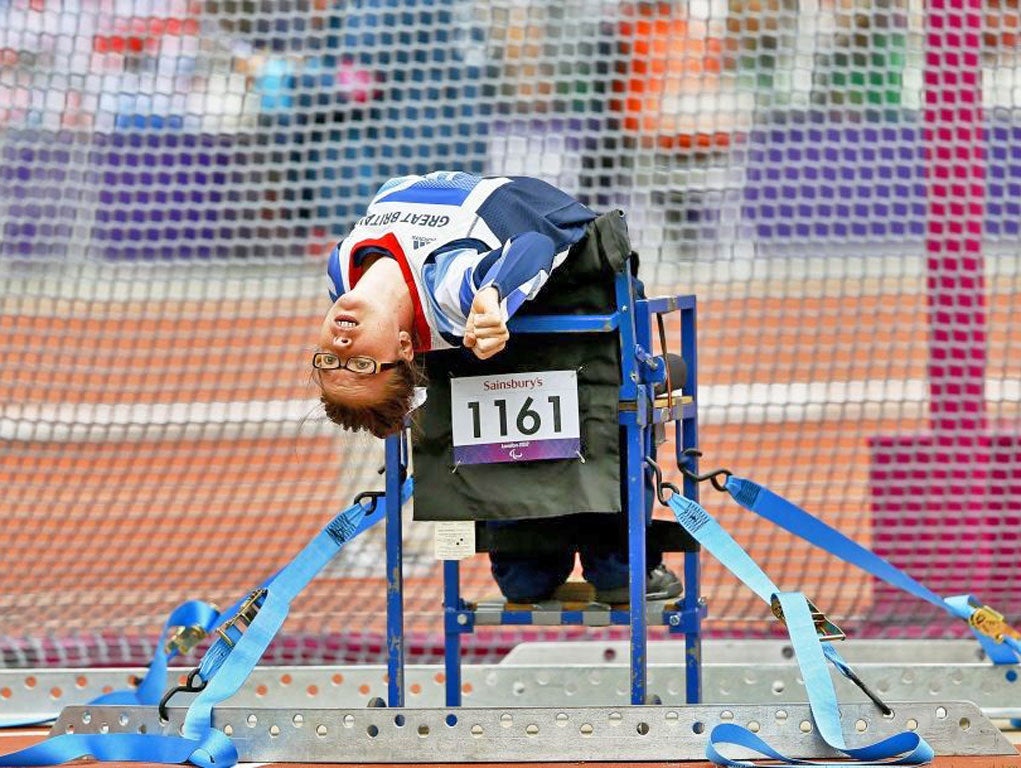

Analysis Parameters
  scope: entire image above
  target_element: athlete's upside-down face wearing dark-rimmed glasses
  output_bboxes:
[317,293,415,404]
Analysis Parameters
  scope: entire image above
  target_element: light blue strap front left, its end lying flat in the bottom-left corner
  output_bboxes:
[0,478,414,768]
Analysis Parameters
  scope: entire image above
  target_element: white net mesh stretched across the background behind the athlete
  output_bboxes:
[0,0,1021,666]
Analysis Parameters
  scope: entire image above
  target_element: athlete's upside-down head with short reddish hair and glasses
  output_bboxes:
[312,291,418,437]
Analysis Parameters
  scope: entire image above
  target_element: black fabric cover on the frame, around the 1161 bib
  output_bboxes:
[411,211,636,520]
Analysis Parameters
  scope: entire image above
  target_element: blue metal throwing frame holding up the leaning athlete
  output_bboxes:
[386,270,706,707]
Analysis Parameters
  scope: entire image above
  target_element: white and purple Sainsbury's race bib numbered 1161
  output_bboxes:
[450,371,581,466]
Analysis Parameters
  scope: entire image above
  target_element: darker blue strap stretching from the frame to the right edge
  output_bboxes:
[726,476,1021,664]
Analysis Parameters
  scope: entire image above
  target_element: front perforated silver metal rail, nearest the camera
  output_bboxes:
[45,702,1017,763]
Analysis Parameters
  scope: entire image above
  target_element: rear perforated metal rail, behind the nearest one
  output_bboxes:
[7,640,1021,726]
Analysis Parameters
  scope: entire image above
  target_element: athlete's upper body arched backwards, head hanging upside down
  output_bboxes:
[312,172,595,437]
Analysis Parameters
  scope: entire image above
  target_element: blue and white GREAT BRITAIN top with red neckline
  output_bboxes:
[327,171,595,351]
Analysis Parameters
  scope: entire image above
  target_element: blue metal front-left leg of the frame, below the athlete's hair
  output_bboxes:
[386,435,404,707]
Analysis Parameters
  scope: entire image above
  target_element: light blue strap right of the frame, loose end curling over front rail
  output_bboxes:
[667,493,933,766]
